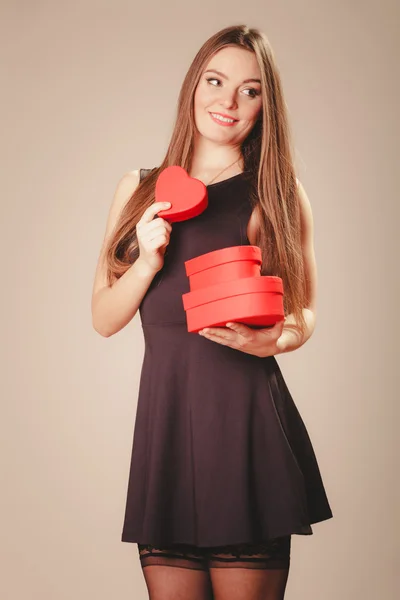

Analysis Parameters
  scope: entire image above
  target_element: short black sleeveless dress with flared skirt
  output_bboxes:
[121,169,333,547]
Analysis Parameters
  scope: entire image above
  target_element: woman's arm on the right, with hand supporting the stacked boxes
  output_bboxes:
[199,181,317,357]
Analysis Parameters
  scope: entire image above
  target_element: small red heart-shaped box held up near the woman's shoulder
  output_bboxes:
[155,165,208,223]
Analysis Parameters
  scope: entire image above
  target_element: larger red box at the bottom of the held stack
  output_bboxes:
[182,276,285,333]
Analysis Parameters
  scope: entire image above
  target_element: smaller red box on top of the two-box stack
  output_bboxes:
[185,246,261,291]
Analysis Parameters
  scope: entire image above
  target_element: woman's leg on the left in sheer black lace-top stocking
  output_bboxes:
[138,544,213,600]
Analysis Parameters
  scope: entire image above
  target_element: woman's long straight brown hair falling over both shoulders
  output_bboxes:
[106,25,307,332]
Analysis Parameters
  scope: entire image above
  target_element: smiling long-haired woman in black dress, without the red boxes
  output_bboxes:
[92,26,332,600]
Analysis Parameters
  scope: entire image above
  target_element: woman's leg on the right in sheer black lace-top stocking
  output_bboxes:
[208,536,291,600]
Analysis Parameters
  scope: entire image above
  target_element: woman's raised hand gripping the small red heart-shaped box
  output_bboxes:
[136,202,172,273]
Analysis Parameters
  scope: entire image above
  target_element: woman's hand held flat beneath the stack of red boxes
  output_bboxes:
[199,320,284,358]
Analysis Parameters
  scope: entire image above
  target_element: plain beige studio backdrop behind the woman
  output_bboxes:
[0,0,400,600]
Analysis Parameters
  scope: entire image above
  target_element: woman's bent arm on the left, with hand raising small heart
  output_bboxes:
[91,170,171,337]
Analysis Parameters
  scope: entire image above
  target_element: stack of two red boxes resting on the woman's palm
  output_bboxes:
[182,246,284,333]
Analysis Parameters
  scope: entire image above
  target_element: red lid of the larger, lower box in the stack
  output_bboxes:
[182,275,283,311]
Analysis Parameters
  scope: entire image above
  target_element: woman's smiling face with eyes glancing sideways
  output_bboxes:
[194,46,262,145]
